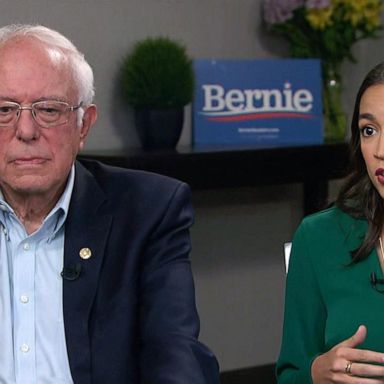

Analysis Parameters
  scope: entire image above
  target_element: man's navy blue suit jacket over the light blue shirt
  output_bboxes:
[63,161,219,384]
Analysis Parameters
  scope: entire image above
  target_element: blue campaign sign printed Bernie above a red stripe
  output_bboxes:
[193,59,323,146]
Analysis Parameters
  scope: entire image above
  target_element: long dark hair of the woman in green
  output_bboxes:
[335,62,384,263]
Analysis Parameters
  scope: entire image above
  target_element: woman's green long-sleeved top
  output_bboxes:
[276,207,384,384]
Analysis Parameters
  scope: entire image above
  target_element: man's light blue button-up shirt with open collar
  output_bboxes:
[0,166,75,384]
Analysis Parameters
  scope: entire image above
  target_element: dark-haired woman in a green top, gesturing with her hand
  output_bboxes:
[277,63,384,384]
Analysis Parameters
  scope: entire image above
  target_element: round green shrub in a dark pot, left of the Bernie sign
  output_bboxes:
[122,37,194,149]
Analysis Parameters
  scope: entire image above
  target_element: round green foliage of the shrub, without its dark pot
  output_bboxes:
[122,37,194,108]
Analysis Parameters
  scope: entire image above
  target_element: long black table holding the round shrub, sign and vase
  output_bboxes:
[79,143,348,213]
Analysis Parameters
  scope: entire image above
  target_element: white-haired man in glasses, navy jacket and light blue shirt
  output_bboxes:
[0,25,218,384]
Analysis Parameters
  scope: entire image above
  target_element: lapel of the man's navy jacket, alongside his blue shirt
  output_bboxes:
[63,162,112,384]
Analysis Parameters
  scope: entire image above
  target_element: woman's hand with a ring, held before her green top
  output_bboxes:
[311,325,384,384]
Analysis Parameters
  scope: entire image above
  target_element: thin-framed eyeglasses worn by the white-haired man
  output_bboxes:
[0,100,82,128]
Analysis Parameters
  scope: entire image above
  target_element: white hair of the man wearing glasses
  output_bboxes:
[0,24,95,107]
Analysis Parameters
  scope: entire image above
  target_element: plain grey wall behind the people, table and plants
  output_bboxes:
[0,0,384,370]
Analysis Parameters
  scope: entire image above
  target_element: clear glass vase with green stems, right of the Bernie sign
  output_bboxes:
[323,66,347,143]
